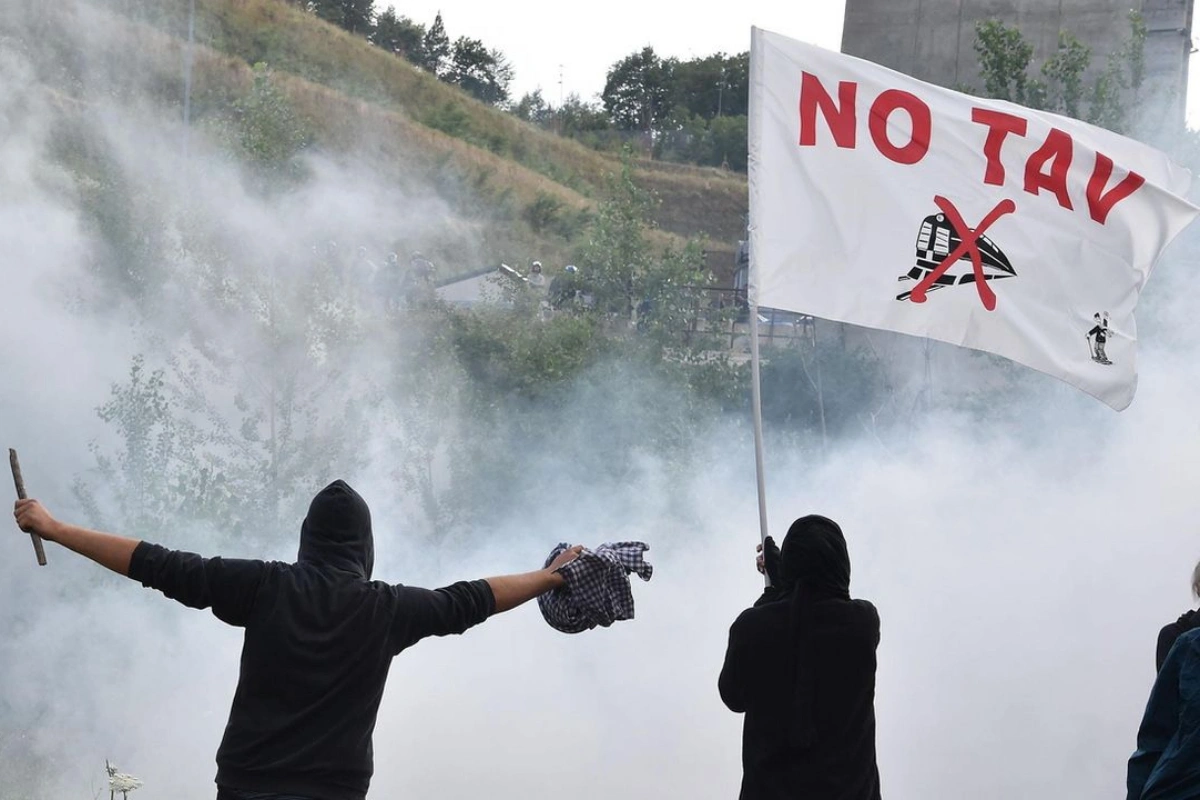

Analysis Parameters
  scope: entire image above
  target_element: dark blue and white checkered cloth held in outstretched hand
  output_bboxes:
[538,542,654,633]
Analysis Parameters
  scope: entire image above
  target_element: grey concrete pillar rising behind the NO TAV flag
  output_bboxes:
[841,0,1194,130]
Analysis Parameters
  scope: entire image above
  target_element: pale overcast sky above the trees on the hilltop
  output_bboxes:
[378,0,1200,127]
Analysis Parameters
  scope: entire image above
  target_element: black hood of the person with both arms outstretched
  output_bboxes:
[296,481,374,579]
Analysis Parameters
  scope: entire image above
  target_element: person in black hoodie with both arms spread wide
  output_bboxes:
[14,481,578,800]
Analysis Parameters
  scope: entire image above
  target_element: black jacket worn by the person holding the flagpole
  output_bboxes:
[719,589,880,800]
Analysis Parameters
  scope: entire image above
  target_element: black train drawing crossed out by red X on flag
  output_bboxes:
[896,197,1016,311]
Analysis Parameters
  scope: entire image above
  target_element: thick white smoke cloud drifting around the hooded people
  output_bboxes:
[0,1,1200,800]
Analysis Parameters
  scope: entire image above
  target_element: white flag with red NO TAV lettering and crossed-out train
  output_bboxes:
[750,29,1198,410]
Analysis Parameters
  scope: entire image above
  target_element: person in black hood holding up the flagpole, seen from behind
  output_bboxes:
[718,516,880,800]
